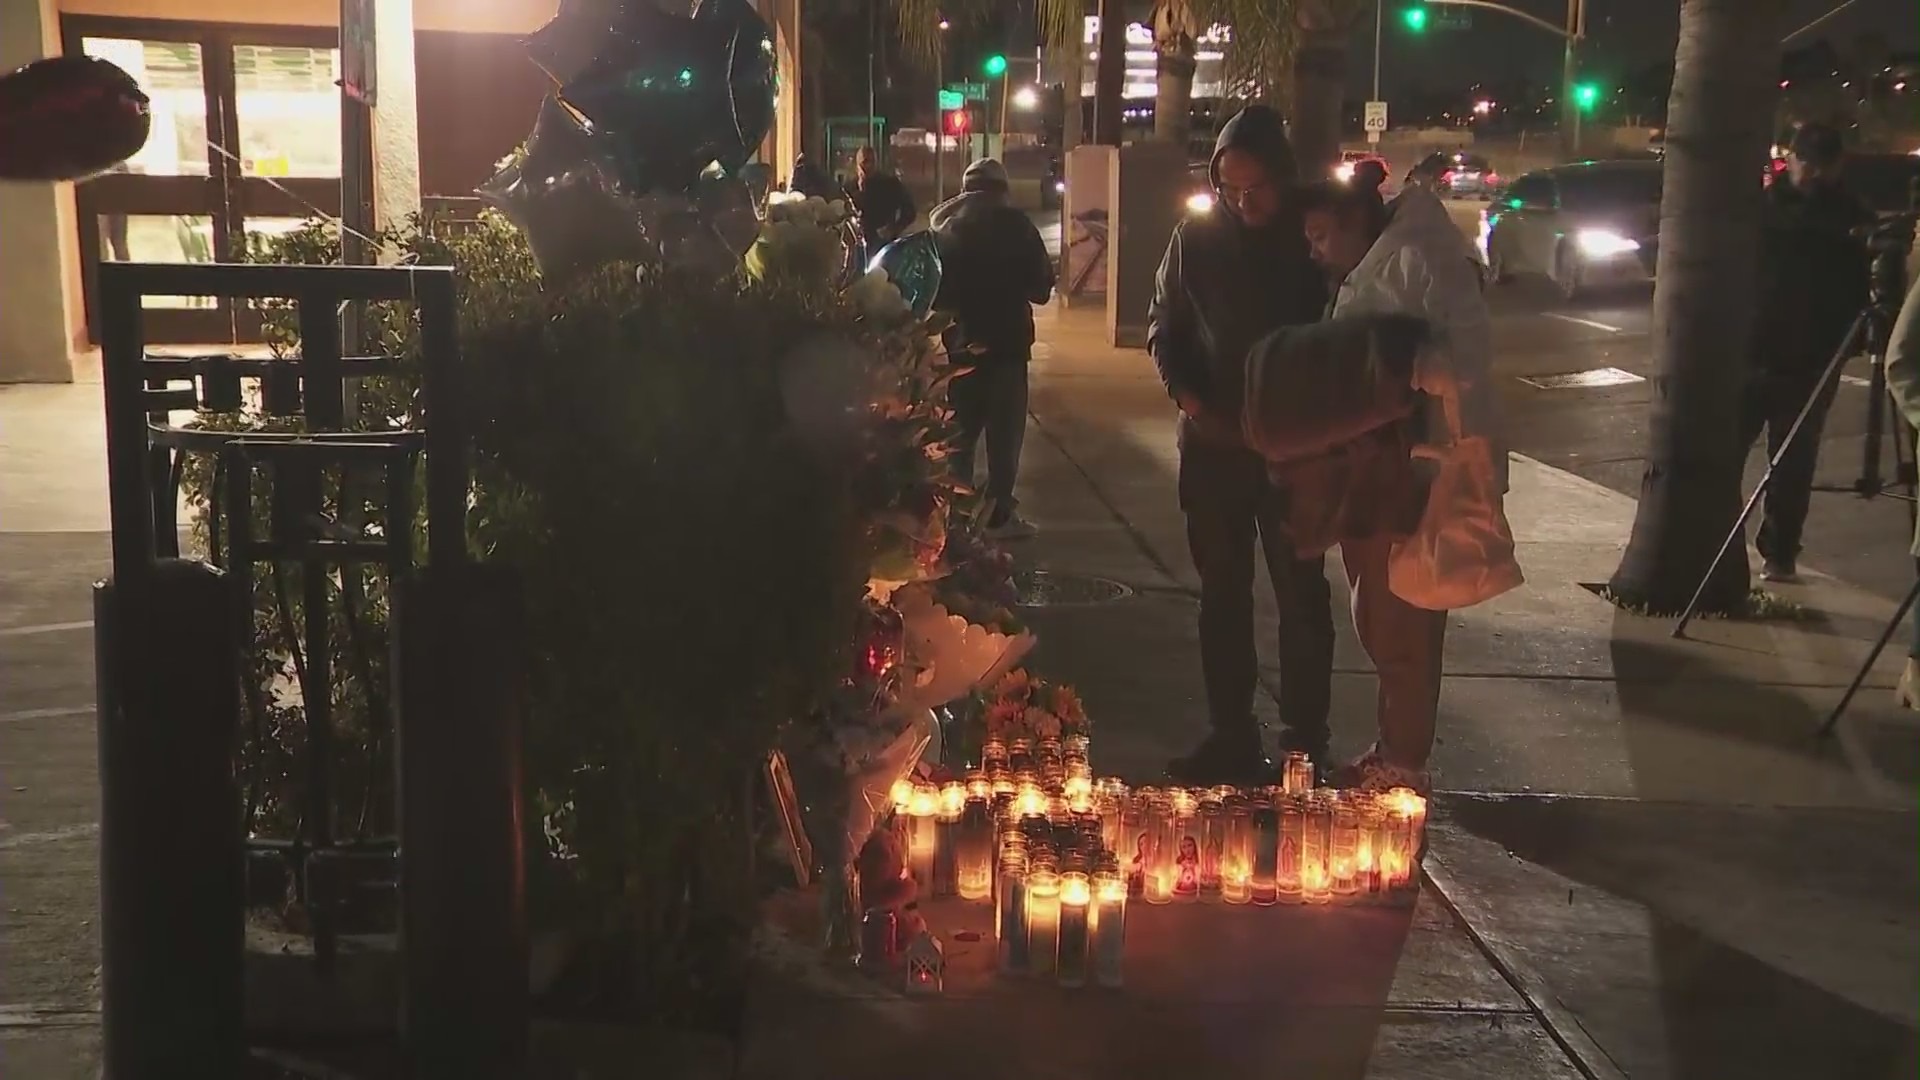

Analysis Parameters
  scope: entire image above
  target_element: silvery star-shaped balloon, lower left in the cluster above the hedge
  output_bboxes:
[480,96,660,282]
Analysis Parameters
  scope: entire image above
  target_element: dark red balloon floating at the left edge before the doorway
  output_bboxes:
[0,56,154,181]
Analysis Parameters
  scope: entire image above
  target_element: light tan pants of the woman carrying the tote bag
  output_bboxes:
[1340,536,1448,769]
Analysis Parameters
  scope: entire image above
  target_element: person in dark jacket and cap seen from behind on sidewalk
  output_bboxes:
[927,158,1054,540]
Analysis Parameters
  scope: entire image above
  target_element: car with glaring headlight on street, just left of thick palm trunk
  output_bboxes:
[1480,160,1663,302]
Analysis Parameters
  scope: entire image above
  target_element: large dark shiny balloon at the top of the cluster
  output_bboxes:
[549,0,776,196]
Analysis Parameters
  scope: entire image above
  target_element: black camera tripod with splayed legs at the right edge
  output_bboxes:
[1672,206,1920,740]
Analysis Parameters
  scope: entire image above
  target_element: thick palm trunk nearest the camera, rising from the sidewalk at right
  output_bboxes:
[1611,0,1782,613]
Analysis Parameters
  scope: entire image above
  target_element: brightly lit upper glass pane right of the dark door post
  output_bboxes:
[234,44,340,179]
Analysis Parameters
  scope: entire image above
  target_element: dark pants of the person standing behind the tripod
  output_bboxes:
[1740,363,1837,563]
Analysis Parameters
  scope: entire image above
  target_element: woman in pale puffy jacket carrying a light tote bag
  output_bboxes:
[1294,181,1507,792]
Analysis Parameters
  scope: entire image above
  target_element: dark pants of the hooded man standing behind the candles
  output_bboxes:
[1179,430,1332,755]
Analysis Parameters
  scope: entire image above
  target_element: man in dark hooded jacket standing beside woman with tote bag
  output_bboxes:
[1146,106,1332,784]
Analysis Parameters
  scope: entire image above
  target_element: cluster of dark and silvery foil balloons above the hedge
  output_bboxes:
[480,0,774,281]
